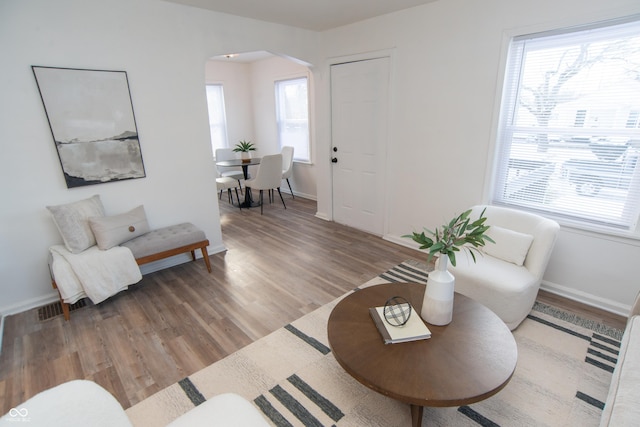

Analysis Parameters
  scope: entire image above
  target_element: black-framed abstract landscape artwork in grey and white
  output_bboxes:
[31,66,145,188]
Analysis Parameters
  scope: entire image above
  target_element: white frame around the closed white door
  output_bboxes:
[326,49,395,237]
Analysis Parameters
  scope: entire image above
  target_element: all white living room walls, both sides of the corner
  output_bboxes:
[5,0,640,320]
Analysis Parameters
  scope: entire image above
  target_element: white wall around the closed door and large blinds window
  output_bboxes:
[317,0,640,312]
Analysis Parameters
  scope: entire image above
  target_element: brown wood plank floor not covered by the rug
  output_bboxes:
[0,195,624,414]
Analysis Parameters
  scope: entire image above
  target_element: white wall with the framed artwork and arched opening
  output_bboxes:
[0,0,318,315]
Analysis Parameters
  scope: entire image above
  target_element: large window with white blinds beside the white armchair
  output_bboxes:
[492,17,640,231]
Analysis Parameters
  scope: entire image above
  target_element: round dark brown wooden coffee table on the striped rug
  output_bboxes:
[327,283,518,426]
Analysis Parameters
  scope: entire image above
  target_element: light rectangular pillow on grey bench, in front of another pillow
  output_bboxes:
[89,205,149,251]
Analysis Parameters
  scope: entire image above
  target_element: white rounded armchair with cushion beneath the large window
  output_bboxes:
[449,205,560,330]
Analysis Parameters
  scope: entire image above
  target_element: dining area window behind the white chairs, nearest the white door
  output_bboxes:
[275,77,311,162]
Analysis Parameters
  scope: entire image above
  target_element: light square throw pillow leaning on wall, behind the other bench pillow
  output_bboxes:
[47,194,104,254]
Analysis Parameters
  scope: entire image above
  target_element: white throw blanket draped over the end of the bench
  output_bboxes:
[49,245,142,304]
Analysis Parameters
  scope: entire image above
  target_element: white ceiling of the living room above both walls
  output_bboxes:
[162,0,437,31]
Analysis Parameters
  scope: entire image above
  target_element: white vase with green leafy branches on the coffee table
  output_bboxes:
[402,209,495,325]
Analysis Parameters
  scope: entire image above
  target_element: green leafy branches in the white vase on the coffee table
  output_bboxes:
[402,209,495,267]
